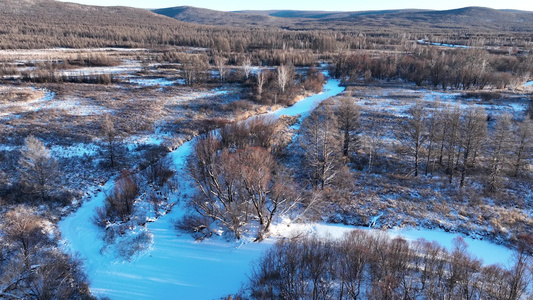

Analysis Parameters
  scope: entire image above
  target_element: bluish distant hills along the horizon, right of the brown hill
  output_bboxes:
[155,7,533,32]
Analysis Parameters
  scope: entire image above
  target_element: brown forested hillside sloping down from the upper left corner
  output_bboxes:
[0,0,224,49]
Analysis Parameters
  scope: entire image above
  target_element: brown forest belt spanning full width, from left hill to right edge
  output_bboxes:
[4,0,531,53]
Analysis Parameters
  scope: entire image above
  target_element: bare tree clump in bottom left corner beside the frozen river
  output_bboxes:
[0,206,91,299]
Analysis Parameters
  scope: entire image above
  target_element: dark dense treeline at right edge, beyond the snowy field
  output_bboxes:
[333,47,533,90]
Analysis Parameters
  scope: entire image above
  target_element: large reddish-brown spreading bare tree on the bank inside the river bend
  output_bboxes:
[182,134,298,240]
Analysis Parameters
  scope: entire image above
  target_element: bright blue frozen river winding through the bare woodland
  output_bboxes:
[59,80,510,299]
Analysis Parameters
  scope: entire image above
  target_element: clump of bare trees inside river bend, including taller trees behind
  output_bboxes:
[181,118,299,240]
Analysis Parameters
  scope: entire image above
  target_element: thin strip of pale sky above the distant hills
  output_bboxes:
[54,0,533,11]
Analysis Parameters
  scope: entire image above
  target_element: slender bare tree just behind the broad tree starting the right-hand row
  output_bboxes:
[337,97,361,157]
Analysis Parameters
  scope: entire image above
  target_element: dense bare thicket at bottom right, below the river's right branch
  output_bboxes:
[243,231,532,300]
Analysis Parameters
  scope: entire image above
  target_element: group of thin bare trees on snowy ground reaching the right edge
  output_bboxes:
[399,102,533,192]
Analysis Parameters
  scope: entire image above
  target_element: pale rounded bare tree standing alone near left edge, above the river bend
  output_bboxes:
[19,135,58,200]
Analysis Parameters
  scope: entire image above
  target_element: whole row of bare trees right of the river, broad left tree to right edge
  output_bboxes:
[299,98,533,193]
